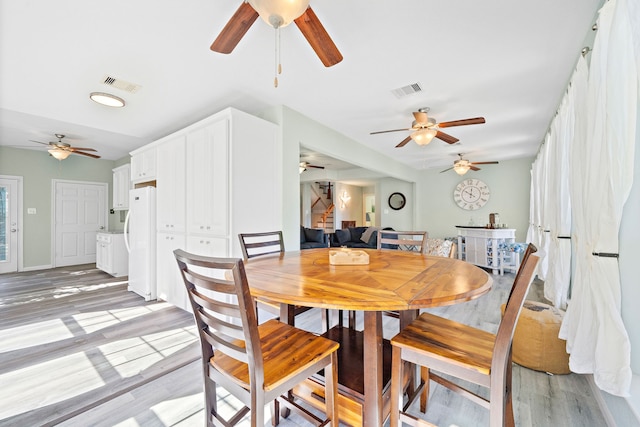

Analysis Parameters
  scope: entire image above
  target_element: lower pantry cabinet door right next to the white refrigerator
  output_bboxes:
[156,233,187,310]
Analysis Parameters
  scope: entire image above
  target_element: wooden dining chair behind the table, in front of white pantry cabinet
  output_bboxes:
[238,231,312,325]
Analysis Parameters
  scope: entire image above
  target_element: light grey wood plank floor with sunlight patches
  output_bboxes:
[0,265,606,427]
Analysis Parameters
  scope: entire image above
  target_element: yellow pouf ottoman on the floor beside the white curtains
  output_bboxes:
[501,301,570,374]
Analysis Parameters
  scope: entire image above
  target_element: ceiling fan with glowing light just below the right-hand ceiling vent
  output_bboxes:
[371,107,485,148]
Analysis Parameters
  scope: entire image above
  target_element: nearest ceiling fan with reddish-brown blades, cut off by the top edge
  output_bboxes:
[211,0,342,67]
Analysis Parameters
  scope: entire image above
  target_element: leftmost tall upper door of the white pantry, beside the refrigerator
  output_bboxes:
[156,136,186,232]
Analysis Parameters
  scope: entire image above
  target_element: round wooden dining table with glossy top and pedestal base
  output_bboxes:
[245,248,493,427]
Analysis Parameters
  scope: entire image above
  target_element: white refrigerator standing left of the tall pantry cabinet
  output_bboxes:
[124,187,157,301]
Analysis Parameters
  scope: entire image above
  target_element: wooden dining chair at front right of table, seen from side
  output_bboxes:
[391,245,539,427]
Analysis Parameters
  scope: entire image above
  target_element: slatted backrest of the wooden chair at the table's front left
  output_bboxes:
[174,249,263,374]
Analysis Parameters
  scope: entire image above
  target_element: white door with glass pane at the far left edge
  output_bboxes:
[0,178,21,273]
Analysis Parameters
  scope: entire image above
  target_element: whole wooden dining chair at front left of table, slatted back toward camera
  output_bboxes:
[174,249,339,427]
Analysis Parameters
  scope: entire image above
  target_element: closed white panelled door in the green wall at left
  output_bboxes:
[53,180,107,267]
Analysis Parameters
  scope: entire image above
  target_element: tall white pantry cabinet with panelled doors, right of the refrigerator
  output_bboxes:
[140,108,282,310]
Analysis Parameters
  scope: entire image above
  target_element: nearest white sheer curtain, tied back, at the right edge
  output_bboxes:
[560,0,638,396]
